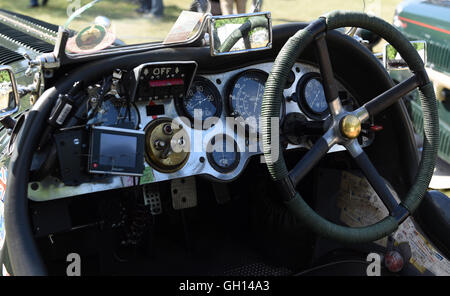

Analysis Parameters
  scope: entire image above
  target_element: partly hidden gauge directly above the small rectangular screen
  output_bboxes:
[88,98,139,129]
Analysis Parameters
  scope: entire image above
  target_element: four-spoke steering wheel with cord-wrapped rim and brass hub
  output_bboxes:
[261,11,439,243]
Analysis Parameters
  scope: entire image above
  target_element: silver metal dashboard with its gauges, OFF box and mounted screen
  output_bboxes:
[28,61,373,201]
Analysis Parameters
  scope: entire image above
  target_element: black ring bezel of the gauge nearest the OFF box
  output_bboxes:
[175,76,223,129]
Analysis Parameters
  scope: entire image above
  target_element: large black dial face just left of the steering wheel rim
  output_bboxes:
[229,70,268,133]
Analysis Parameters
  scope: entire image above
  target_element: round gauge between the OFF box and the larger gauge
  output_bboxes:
[181,77,222,126]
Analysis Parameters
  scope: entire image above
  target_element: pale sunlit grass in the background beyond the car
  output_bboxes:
[0,0,401,44]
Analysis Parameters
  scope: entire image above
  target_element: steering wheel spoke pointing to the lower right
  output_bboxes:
[345,139,398,213]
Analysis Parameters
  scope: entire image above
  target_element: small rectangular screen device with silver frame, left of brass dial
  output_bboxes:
[88,126,145,176]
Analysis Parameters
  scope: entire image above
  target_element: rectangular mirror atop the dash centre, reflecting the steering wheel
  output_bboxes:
[209,12,272,56]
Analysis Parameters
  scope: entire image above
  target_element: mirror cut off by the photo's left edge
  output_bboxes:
[0,66,19,118]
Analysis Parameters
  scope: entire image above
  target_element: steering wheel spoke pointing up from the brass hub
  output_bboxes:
[316,33,342,116]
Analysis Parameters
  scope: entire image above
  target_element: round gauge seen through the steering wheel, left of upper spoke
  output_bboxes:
[297,72,329,119]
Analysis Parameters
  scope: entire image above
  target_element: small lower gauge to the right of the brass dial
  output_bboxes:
[206,135,240,173]
